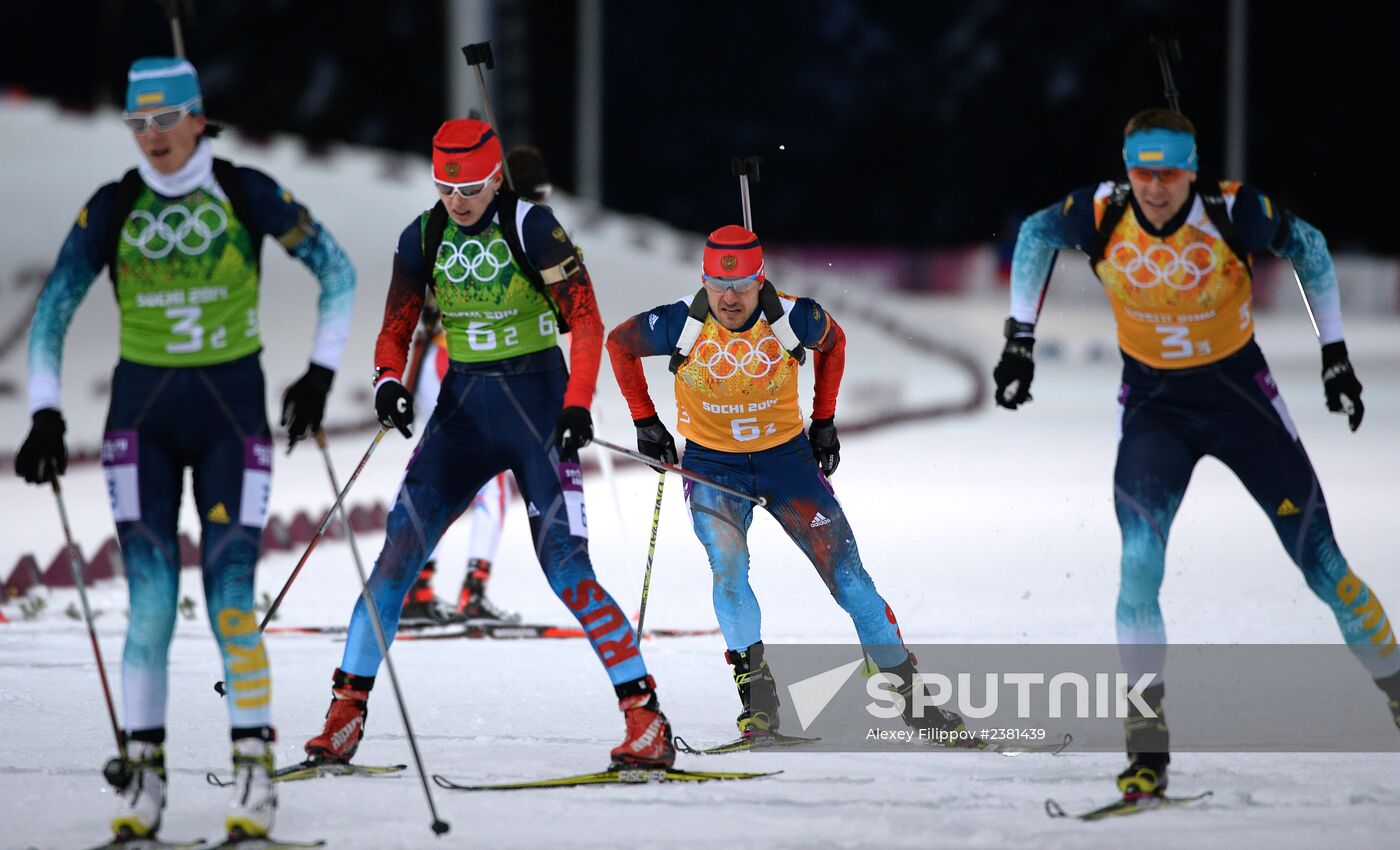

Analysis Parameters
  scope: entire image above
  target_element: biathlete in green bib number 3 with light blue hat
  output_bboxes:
[15,57,354,840]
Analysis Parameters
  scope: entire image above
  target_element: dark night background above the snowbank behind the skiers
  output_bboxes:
[0,0,1400,253]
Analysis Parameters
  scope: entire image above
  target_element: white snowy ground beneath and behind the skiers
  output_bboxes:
[0,102,1400,849]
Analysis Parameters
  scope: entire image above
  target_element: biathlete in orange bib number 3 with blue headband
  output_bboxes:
[994,109,1400,795]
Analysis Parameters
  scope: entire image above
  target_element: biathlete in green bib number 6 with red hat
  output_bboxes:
[307,119,675,767]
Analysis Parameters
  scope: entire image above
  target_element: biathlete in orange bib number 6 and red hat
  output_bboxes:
[608,225,962,738]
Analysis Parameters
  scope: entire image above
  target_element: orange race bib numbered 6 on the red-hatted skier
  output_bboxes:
[676,305,802,452]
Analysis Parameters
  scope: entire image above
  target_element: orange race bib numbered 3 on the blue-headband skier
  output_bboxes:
[1093,182,1254,368]
